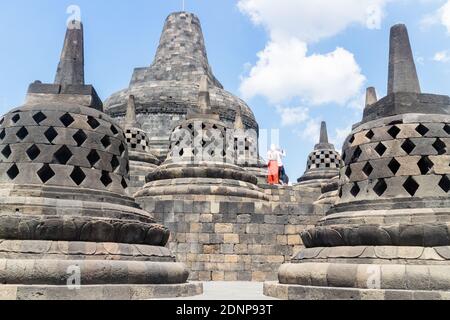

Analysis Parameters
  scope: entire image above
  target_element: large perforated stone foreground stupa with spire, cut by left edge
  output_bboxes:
[0,21,202,300]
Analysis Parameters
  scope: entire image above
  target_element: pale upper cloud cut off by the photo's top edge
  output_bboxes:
[238,0,389,42]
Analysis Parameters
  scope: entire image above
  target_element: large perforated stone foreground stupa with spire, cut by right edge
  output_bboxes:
[265,25,450,299]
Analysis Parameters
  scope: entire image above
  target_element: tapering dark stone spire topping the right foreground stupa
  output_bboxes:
[388,24,420,94]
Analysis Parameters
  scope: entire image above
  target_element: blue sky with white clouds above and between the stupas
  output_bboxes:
[0,0,450,180]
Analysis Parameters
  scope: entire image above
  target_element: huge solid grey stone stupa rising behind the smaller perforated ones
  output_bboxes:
[105,12,258,160]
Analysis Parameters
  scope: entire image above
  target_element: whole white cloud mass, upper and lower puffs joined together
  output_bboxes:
[238,0,392,106]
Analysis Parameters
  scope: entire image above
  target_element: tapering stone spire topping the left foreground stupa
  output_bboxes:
[55,20,84,85]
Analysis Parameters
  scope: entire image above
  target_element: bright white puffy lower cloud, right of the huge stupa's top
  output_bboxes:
[241,38,365,105]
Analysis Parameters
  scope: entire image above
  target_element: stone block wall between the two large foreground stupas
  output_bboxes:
[138,186,328,281]
